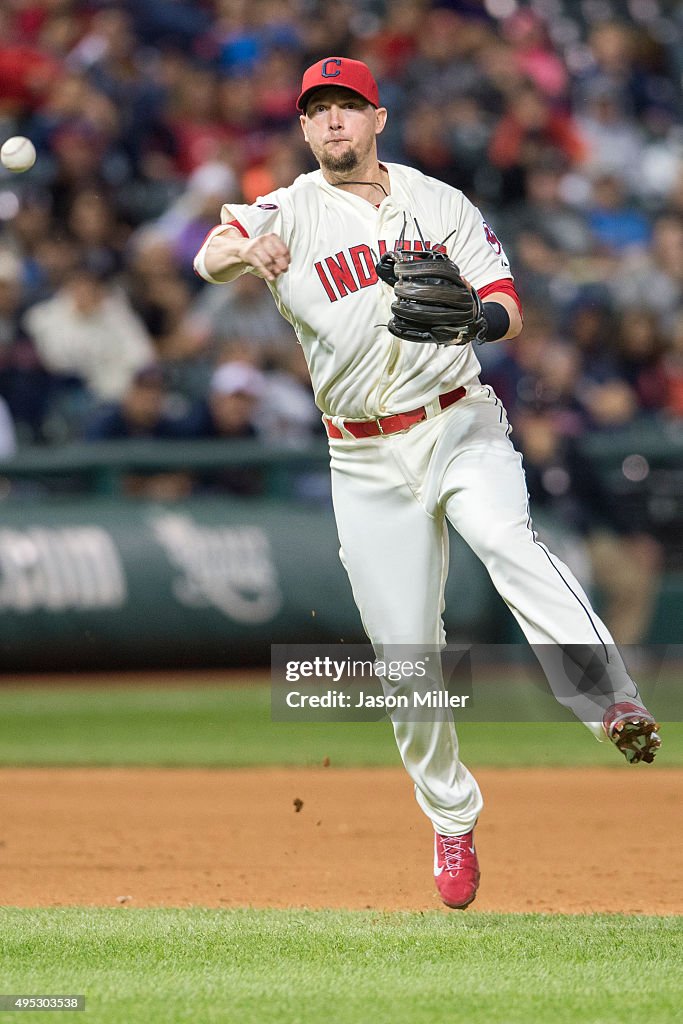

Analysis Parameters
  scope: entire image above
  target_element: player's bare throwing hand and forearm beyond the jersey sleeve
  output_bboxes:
[195,226,291,282]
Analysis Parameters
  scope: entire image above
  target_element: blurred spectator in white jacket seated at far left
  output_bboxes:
[24,262,155,408]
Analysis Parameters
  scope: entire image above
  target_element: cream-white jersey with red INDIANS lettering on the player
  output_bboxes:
[195,164,512,420]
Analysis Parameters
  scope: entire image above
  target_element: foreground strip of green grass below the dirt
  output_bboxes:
[0,908,683,1024]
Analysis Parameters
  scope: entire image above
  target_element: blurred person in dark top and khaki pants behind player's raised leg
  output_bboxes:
[514,401,661,647]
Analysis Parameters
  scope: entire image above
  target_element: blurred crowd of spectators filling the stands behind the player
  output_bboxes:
[0,0,683,453]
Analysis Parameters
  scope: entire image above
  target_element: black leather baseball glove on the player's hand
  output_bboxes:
[376,250,486,345]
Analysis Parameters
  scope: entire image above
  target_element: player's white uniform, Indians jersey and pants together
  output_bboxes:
[195,155,637,836]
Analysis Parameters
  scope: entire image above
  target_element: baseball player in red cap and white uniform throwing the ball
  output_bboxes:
[195,57,659,908]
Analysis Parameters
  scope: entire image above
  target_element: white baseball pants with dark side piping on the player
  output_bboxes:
[330,384,637,835]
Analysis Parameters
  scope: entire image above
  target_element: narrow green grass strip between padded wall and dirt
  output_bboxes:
[0,680,683,770]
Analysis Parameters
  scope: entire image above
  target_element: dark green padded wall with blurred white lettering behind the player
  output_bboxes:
[0,498,507,674]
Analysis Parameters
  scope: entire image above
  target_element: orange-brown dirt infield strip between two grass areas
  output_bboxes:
[0,766,683,913]
